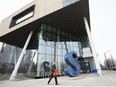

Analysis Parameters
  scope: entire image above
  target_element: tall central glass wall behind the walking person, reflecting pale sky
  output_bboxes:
[37,24,81,77]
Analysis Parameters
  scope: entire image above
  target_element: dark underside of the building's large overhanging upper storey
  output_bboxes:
[0,0,90,48]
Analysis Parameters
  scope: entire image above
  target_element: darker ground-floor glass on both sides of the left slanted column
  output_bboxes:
[0,40,38,79]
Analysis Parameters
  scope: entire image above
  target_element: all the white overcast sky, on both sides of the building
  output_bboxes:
[0,0,116,64]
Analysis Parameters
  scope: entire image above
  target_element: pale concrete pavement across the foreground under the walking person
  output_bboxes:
[0,71,116,87]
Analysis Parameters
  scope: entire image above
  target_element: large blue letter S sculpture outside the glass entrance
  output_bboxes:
[64,51,80,77]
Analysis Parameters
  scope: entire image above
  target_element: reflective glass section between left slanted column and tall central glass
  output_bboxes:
[21,50,37,76]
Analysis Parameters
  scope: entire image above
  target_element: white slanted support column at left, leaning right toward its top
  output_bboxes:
[10,31,33,80]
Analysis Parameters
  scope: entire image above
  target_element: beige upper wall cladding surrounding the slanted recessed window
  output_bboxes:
[0,0,62,37]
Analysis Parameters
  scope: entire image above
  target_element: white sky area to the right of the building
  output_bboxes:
[89,0,116,62]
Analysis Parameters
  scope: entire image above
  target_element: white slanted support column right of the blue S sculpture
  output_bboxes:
[83,17,101,75]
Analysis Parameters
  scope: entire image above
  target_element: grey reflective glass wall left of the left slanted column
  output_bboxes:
[0,44,22,77]
